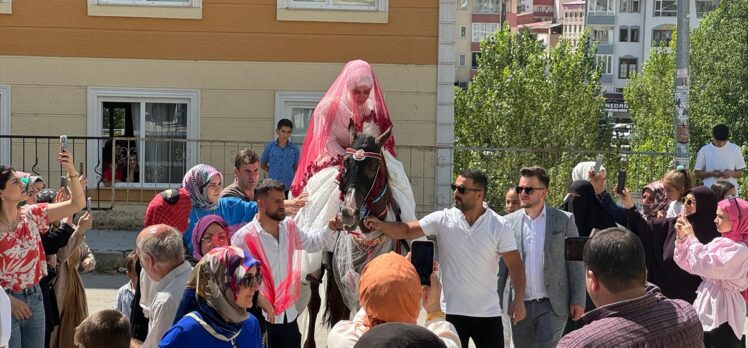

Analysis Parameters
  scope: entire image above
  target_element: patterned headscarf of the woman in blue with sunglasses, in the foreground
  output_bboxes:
[193,246,260,328]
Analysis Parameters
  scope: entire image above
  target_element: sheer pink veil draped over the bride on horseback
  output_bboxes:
[291,60,397,196]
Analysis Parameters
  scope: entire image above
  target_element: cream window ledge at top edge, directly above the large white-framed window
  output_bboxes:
[88,0,203,19]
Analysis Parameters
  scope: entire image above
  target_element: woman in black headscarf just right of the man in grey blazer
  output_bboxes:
[561,180,616,237]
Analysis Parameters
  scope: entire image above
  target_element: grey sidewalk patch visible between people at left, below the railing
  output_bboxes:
[86,229,140,272]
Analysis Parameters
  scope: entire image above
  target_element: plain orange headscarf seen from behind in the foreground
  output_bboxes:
[358,252,423,328]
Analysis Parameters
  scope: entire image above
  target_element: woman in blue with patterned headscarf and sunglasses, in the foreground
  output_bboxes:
[159,246,262,348]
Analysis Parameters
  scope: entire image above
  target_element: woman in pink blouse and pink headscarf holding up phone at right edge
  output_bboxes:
[675,198,748,348]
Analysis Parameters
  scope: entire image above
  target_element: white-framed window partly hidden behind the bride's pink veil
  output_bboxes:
[273,92,325,146]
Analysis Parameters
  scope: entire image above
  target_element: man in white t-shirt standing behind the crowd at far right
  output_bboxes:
[693,124,745,192]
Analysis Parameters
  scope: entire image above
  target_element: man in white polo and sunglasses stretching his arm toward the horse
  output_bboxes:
[366,170,525,348]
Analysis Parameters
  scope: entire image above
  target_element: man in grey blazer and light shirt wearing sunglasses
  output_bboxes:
[499,167,586,347]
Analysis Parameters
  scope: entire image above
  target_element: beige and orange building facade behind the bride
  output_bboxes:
[0,0,456,222]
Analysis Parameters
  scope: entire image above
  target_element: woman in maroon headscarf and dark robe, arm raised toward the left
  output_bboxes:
[619,186,719,303]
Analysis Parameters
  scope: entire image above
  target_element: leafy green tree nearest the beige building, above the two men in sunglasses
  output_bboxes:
[455,26,610,207]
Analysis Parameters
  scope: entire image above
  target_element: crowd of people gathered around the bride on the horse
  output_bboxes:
[0,61,748,348]
